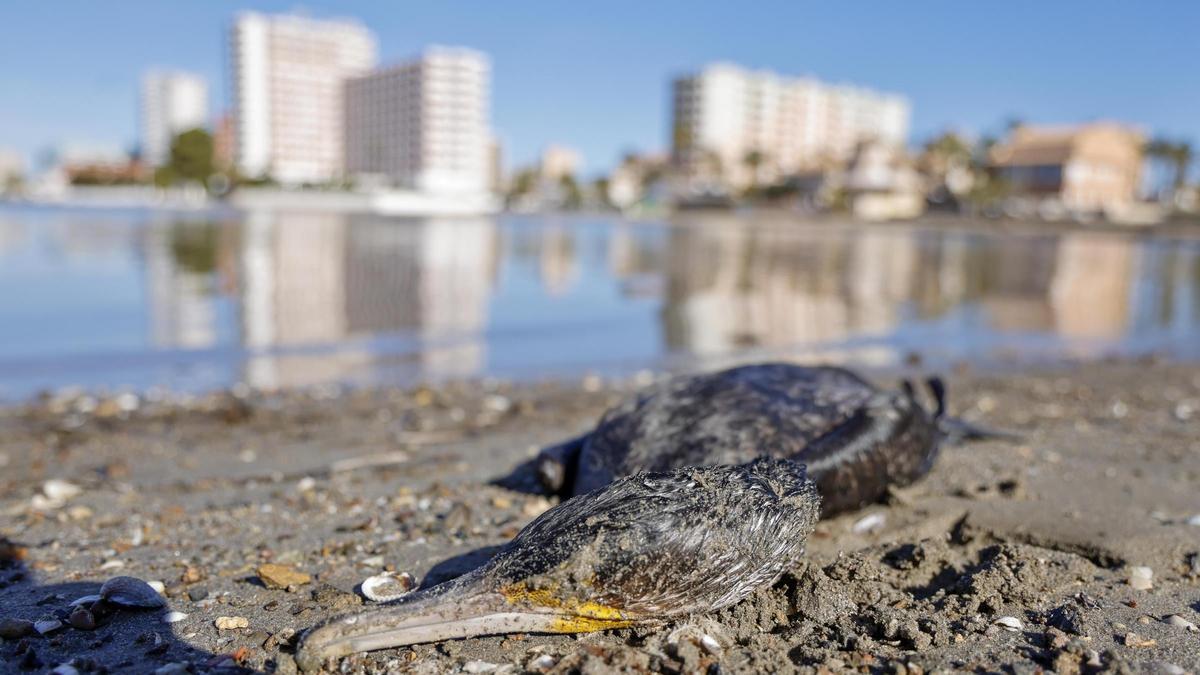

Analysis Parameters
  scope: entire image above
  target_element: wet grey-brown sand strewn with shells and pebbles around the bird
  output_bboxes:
[0,362,1200,675]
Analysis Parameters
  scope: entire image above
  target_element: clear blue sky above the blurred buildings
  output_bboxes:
[0,0,1200,176]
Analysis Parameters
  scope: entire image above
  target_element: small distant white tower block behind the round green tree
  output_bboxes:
[142,71,209,167]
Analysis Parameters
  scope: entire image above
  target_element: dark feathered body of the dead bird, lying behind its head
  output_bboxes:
[536,363,1008,515]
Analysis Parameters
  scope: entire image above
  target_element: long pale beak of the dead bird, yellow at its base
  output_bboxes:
[296,571,630,673]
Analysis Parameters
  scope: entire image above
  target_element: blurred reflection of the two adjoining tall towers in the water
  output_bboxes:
[240,213,497,388]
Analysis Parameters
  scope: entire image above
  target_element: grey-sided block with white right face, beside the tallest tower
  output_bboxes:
[346,47,494,193]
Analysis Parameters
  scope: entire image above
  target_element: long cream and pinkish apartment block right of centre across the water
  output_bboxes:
[672,64,910,185]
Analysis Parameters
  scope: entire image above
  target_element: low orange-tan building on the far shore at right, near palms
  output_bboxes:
[990,123,1145,213]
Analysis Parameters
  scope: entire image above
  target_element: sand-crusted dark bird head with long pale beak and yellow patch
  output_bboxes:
[296,458,820,670]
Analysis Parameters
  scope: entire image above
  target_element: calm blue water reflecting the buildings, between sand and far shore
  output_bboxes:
[0,201,1200,399]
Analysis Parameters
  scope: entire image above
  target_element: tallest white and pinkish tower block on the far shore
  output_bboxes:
[229,12,376,185]
